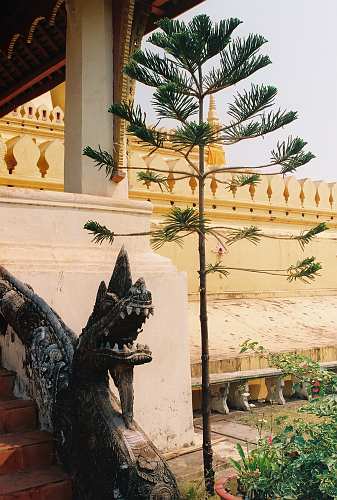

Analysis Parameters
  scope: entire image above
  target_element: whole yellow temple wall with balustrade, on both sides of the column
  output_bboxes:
[0,104,337,299]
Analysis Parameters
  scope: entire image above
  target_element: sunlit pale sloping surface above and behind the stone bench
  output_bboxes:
[189,296,337,363]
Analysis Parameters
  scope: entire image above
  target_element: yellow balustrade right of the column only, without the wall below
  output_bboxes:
[129,136,337,224]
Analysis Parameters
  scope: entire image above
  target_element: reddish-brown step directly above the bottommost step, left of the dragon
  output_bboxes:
[0,431,55,474]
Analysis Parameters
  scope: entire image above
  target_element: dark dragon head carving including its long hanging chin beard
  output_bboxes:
[76,247,153,427]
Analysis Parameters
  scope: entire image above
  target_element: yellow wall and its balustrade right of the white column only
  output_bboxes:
[129,140,337,300]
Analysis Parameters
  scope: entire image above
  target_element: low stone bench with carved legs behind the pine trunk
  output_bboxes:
[192,361,337,414]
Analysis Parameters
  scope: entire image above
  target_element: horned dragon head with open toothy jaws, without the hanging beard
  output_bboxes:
[80,247,153,368]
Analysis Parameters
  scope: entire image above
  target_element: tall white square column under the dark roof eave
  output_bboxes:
[64,0,128,198]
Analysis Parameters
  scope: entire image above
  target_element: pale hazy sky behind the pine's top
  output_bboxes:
[137,0,337,180]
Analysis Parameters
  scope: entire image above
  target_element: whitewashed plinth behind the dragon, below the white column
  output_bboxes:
[0,187,193,449]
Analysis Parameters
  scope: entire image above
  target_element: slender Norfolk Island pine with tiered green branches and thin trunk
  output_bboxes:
[83,15,327,494]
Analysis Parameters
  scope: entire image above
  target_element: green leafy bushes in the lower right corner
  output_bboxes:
[228,346,337,500]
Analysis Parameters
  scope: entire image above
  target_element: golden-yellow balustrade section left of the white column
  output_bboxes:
[0,103,64,191]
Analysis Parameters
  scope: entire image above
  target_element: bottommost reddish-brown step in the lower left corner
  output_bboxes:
[0,466,72,500]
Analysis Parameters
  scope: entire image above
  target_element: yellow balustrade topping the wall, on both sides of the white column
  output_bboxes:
[0,108,337,223]
